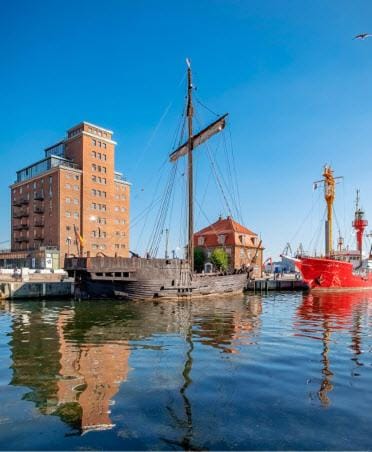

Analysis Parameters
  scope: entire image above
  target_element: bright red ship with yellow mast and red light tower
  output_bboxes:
[286,166,372,293]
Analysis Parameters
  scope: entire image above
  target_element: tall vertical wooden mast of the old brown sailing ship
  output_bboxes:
[186,59,194,272]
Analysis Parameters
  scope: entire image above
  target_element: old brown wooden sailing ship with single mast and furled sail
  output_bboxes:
[65,60,248,299]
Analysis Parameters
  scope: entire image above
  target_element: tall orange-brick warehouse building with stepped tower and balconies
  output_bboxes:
[10,122,130,266]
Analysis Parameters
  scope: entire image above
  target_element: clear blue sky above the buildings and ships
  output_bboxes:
[0,0,372,256]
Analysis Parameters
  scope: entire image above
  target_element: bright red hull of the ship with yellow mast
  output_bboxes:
[293,257,372,293]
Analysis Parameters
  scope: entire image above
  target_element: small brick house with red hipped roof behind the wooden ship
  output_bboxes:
[194,217,264,276]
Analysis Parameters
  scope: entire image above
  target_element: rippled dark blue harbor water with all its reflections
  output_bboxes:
[0,292,372,450]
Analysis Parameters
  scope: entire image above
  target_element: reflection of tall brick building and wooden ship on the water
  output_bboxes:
[8,297,262,440]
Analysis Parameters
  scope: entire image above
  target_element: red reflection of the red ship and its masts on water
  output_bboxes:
[295,292,372,407]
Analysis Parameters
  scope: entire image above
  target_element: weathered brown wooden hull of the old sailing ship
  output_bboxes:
[66,257,248,300]
